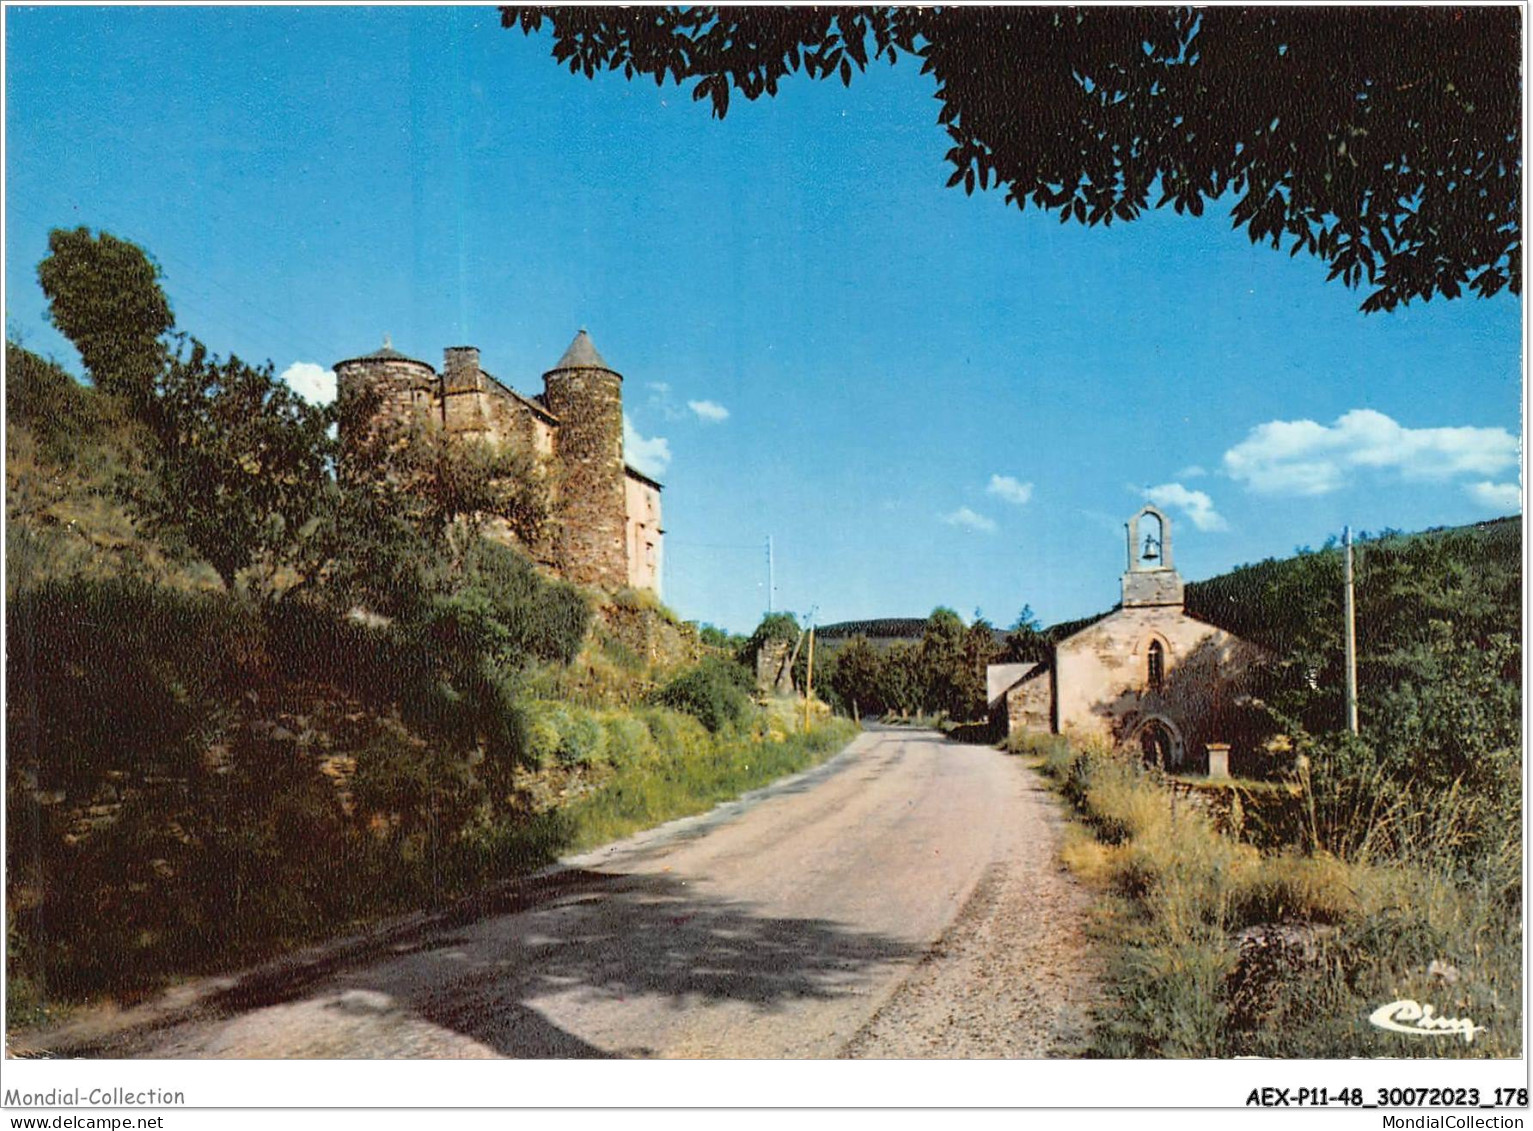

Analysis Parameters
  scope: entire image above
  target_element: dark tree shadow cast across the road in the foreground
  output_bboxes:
[111,870,920,1057]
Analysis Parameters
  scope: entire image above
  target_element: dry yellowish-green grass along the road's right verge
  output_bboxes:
[1042,742,1522,1057]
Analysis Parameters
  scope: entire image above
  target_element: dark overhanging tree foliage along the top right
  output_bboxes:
[501,6,1522,311]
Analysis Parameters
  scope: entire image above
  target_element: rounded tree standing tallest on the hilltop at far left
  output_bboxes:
[37,228,175,408]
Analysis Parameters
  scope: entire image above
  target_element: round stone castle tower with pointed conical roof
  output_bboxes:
[543,329,629,592]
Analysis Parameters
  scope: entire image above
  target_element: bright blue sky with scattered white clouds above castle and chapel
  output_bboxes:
[5,8,1522,630]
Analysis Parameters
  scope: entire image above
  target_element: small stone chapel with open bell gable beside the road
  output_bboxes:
[986,506,1263,772]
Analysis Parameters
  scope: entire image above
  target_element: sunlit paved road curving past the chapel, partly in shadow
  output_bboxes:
[59,729,1093,1057]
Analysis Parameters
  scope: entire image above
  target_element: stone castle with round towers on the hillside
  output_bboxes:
[334,329,664,595]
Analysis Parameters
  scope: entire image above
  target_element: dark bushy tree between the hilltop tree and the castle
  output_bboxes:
[130,339,330,588]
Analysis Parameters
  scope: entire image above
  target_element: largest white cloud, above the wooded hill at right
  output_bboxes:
[1225,409,1518,495]
